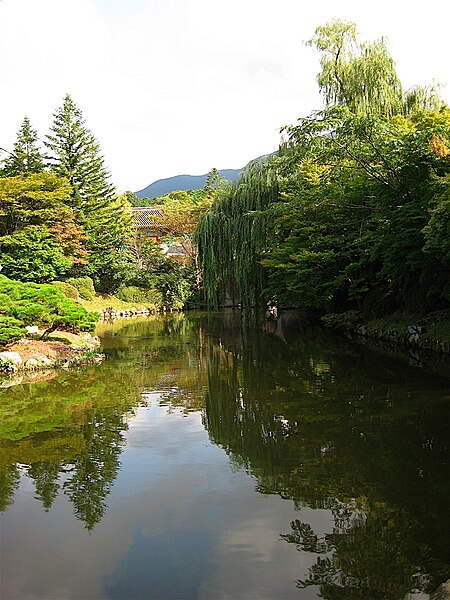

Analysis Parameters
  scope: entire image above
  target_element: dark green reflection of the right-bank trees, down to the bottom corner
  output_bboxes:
[205,318,450,600]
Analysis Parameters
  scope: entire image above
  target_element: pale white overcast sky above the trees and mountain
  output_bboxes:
[0,0,450,192]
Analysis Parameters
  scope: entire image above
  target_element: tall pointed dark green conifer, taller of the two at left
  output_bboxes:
[45,94,114,212]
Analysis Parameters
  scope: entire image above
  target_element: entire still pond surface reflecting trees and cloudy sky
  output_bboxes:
[0,312,450,600]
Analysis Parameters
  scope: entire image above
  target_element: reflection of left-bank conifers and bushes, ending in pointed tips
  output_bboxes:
[0,365,141,529]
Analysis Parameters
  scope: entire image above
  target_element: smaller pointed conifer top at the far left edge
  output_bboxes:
[2,117,44,177]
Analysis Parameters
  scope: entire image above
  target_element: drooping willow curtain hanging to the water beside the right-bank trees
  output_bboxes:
[197,161,277,308]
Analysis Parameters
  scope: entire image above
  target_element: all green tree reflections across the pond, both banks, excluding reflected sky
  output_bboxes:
[0,312,450,600]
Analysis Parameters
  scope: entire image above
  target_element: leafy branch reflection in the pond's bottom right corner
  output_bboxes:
[281,502,446,600]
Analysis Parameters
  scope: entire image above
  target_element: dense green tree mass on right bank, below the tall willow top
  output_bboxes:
[199,99,450,316]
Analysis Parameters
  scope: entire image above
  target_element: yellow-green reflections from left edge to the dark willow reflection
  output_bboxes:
[0,314,206,530]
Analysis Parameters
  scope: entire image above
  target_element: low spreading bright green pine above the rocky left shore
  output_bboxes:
[0,275,98,343]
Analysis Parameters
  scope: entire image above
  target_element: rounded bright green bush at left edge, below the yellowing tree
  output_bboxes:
[0,226,72,283]
